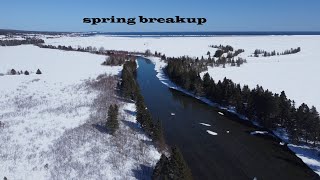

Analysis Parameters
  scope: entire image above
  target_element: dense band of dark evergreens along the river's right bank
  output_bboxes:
[165,59,320,145]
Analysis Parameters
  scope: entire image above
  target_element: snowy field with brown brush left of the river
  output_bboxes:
[0,45,160,179]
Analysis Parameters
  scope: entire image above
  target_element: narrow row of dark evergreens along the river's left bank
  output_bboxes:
[120,61,192,180]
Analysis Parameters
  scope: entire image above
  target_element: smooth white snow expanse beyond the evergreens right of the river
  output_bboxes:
[45,36,320,109]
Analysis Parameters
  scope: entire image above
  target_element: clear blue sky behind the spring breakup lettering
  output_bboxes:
[0,0,320,32]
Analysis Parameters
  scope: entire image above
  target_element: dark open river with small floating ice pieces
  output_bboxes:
[137,58,317,180]
